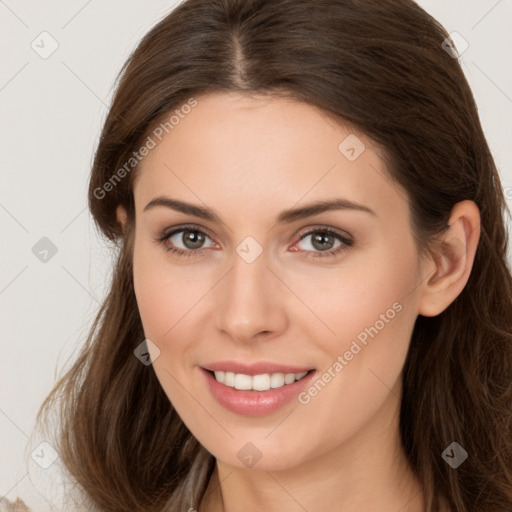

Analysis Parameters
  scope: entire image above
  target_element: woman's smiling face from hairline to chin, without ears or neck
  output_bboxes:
[130,94,425,470]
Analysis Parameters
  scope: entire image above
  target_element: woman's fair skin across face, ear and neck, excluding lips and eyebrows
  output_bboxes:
[117,93,480,512]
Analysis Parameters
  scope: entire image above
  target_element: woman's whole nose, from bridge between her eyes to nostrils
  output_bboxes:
[212,237,284,340]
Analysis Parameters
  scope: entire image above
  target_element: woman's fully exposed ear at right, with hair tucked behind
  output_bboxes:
[418,201,480,316]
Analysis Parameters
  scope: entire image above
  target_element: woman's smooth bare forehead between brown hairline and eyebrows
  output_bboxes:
[134,93,406,226]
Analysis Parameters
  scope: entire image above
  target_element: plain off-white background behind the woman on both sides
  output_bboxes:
[0,0,512,510]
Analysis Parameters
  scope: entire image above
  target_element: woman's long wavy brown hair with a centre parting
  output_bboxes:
[38,0,512,512]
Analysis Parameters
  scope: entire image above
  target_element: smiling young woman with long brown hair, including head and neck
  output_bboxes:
[23,0,512,512]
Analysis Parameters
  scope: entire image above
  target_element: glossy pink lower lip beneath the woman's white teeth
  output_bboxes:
[200,368,316,416]
